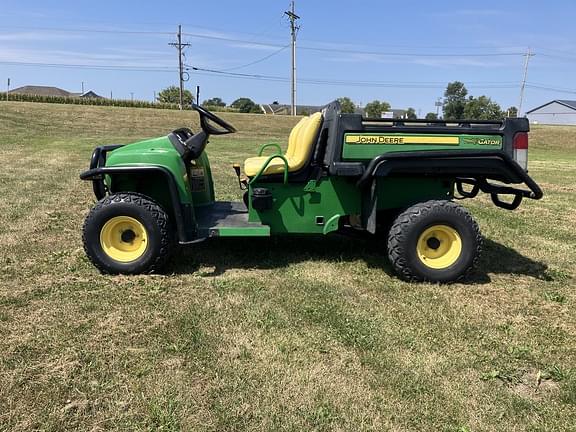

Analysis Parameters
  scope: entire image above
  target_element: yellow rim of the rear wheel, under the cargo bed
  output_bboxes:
[416,225,462,270]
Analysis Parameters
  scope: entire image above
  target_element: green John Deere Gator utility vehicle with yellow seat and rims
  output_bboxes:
[80,102,542,282]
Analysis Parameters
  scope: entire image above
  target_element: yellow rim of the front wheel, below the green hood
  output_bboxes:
[100,216,148,263]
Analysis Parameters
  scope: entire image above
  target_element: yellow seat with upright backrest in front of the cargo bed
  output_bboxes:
[244,113,322,177]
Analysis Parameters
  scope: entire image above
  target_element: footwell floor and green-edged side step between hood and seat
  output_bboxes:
[195,201,270,237]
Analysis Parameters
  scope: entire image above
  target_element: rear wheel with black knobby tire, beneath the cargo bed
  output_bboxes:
[388,201,482,283]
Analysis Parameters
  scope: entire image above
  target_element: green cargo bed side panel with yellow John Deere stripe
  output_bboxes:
[342,133,503,160]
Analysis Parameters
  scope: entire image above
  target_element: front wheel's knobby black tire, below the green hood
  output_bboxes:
[82,193,174,274]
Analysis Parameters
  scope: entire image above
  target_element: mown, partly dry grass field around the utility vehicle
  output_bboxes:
[0,102,576,432]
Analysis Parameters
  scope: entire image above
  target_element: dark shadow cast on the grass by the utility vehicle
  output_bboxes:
[168,235,552,284]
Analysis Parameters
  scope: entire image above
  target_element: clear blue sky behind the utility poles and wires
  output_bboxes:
[0,0,576,116]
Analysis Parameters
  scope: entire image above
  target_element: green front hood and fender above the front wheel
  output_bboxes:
[106,137,192,204]
